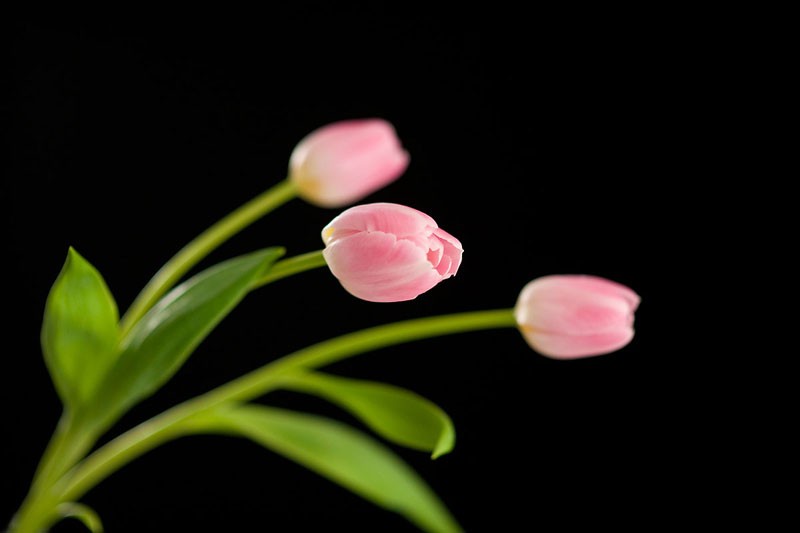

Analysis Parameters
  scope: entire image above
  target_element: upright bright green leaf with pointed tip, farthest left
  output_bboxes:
[41,247,119,406]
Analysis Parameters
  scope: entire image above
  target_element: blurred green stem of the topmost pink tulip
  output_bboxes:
[120,179,297,337]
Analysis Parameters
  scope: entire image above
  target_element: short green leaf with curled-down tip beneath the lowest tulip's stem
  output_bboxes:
[281,372,455,459]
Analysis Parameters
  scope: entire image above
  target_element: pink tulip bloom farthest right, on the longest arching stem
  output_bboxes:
[514,275,639,359]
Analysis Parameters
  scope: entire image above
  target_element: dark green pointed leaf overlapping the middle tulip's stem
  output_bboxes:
[92,248,284,422]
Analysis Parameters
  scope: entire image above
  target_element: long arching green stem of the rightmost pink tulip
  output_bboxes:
[57,309,517,501]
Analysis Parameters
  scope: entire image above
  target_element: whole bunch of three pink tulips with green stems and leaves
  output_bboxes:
[9,119,639,533]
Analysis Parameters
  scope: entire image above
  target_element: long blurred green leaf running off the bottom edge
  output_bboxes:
[210,405,462,533]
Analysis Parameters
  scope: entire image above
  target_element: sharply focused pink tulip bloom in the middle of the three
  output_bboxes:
[322,203,463,302]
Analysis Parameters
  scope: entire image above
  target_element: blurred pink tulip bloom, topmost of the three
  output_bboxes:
[289,119,409,207]
